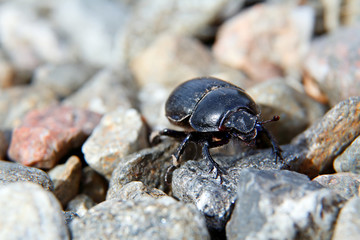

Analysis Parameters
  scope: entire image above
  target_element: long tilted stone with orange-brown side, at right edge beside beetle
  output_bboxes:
[292,97,360,177]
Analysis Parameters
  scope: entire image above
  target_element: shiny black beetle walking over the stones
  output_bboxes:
[158,77,282,182]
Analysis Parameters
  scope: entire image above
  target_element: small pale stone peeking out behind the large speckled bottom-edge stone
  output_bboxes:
[106,181,167,201]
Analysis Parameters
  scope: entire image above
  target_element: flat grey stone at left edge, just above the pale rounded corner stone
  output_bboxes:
[0,161,54,191]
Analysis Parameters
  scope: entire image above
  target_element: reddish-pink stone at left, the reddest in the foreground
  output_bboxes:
[8,106,100,168]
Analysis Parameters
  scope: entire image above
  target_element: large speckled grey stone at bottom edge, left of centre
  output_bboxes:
[70,197,210,240]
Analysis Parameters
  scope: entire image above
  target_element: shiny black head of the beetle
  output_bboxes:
[225,110,257,133]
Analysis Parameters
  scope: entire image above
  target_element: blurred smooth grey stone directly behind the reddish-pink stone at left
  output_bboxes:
[32,62,96,98]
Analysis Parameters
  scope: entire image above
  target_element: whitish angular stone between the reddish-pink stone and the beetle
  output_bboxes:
[82,108,147,179]
